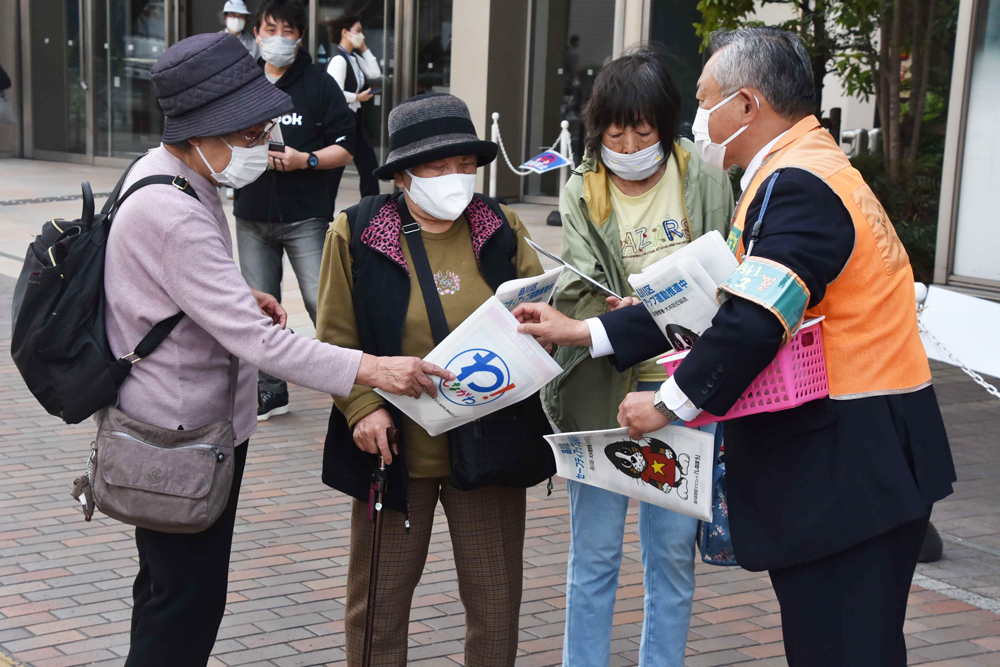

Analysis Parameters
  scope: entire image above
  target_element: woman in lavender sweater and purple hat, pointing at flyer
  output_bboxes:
[104,33,453,667]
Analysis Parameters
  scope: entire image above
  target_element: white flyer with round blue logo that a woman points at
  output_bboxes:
[375,296,562,435]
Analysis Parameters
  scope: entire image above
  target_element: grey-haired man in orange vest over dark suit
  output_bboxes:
[515,28,955,667]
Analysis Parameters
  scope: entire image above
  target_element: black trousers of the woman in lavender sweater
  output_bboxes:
[125,443,249,667]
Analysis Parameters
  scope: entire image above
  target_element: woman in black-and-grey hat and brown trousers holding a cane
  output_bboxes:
[316,94,554,667]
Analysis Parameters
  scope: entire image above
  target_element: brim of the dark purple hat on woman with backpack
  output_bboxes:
[163,76,294,144]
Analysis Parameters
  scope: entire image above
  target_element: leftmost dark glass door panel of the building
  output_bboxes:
[28,0,93,161]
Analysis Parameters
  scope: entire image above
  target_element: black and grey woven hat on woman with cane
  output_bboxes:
[373,93,497,181]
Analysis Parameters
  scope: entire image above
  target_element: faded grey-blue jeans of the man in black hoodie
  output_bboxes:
[236,218,330,394]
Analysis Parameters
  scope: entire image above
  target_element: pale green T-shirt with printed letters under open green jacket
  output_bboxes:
[608,154,691,382]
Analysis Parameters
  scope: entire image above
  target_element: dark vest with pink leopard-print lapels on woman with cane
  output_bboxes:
[323,194,517,513]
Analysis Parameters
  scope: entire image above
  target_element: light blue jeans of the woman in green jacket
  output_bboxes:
[563,383,715,667]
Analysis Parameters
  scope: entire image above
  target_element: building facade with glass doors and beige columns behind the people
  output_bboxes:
[0,0,873,202]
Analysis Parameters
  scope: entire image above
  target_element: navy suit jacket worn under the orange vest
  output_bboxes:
[600,168,955,570]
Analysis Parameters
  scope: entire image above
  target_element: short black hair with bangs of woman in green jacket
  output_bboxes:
[583,45,681,160]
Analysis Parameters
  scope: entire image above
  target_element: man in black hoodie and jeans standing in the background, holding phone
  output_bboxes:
[233,0,354,420]
